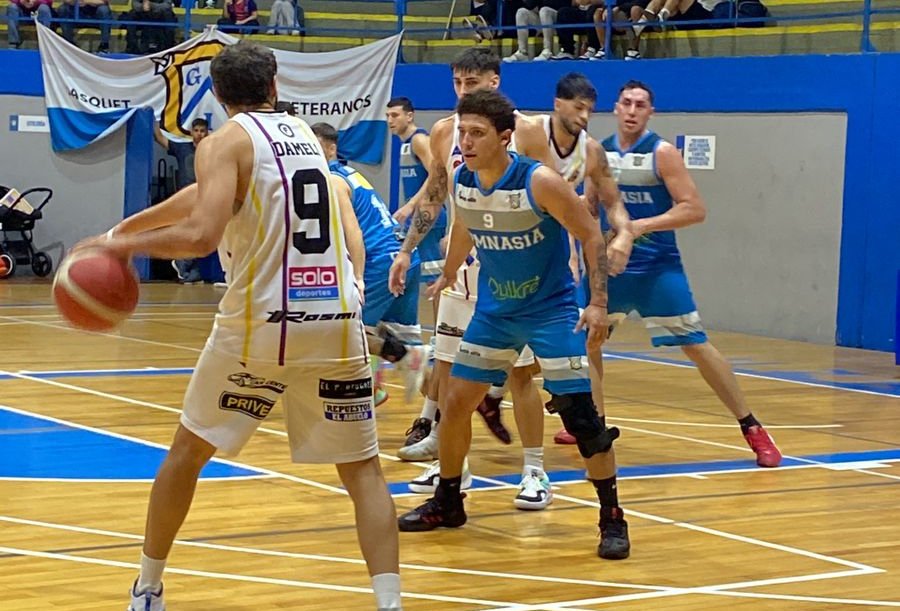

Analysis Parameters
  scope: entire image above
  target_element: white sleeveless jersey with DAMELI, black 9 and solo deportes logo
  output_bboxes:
[208,112,366,365]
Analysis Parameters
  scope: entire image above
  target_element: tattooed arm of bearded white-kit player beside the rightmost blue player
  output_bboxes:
[584,138,634,276]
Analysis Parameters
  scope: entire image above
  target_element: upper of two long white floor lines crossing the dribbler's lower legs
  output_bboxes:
[0,516,671,591]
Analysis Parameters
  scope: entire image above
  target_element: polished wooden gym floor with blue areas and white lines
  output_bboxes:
[0,280,900,611]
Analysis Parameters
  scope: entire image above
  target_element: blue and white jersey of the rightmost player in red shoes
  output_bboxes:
[602,131,681,274]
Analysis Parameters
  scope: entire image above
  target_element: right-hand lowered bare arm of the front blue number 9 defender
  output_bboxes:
[531,166,609,351]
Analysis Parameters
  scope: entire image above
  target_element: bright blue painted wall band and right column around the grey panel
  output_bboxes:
[0,50,900,350]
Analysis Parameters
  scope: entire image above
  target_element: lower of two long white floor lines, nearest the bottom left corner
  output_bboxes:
[0,546,522,611]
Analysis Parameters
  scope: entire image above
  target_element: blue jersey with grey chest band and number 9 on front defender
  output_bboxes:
[452,153,575,315]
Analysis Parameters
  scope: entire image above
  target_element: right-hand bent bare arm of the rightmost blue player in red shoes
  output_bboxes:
[633,142,706,237]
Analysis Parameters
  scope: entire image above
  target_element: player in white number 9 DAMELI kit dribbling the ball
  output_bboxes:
[81,41,401,611]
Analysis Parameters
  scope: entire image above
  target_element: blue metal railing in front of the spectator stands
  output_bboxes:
[3,0,900,61]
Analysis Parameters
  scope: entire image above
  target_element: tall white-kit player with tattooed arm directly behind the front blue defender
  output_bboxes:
[391,47,568,509]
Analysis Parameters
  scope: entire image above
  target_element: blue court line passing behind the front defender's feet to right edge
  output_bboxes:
[388,448,900,494]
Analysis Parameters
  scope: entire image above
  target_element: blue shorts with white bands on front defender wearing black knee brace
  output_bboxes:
[450,302,591,395]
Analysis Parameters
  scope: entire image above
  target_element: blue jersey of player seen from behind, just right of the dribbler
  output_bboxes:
[328,161,418,263]
